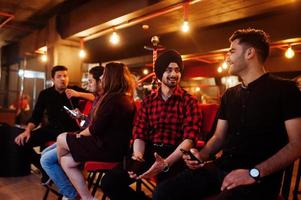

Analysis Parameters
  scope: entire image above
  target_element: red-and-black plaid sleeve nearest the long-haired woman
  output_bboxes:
[133,99,149,141]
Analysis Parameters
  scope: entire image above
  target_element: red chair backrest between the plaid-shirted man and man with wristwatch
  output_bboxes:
[199,103,219,141]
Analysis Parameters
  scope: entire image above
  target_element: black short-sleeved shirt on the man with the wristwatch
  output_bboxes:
[218,73,301,171]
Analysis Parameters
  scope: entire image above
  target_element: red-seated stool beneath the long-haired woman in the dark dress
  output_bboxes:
[84,161,120,200]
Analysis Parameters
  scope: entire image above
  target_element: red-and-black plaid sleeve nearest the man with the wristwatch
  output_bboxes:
[183,96,202,142]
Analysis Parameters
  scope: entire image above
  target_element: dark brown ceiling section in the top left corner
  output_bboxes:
[0,0,87,47]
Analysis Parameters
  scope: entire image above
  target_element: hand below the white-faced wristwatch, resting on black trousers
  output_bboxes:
[221,169,256,191]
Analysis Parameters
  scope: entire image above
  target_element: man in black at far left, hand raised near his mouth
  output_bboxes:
[15,66,94,184]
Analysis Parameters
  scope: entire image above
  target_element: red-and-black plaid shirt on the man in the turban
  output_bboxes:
[133,86,201,145]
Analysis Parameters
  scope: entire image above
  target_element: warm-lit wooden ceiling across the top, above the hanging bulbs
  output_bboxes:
[0,0,301,77]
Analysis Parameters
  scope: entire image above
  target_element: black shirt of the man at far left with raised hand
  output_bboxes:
[29,86,86,132]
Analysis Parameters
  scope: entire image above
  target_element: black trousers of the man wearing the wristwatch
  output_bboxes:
[153,163,278,200]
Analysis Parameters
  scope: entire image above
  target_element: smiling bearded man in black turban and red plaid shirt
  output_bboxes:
[101,50,201,200]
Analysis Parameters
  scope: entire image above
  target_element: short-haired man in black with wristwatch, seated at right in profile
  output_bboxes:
[153,29,301,200]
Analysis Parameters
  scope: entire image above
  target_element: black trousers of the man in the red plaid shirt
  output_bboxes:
[101,144,185,200]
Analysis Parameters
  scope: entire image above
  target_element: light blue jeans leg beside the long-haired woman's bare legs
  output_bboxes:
[40,143,77,198]
